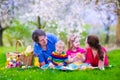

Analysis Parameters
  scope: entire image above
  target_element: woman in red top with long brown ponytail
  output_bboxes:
[85,35,108,69]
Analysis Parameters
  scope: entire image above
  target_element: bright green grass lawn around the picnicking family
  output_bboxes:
[0,47,120,80]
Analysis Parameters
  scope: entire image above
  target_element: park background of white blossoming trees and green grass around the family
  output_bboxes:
[0,0,120,80]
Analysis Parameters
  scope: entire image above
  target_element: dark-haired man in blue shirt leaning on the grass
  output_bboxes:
[32,29,58,66]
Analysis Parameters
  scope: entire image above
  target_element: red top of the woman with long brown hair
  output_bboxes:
[86,47,108,67]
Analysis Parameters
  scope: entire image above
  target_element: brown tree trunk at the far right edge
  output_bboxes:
[116,16,120,47]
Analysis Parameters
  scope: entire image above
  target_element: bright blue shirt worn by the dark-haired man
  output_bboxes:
[34,33,58,63]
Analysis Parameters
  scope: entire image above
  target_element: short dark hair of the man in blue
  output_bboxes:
[32,29,46,43]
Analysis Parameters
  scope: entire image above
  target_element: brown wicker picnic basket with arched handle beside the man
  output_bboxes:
[6,40,33,66]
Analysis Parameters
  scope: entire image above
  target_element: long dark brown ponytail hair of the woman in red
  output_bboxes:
[87,35,104,61]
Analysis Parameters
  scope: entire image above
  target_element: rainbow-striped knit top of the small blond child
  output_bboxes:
[48,52,68,66]
